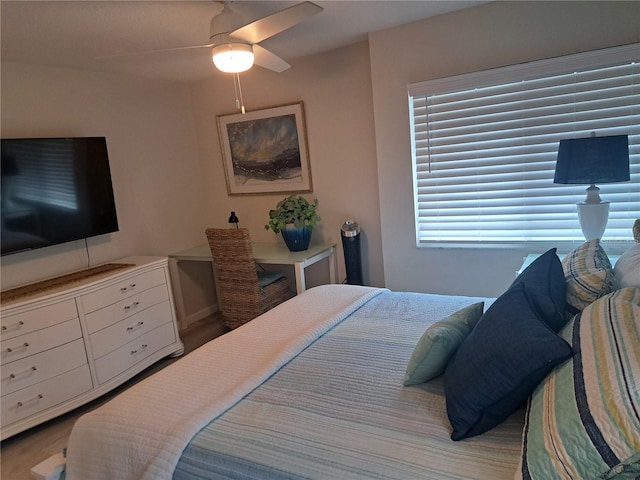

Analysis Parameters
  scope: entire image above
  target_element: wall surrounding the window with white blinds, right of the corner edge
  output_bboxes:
[369,1,640,296]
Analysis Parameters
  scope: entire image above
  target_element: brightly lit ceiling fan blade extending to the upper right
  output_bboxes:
[230,2,323,43]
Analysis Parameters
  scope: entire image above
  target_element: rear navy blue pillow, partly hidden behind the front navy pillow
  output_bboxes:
[510,248,568,332]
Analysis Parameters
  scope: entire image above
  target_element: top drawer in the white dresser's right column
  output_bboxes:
[80,268,167,313]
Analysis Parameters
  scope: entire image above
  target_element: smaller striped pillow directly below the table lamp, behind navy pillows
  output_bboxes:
[562,239,617,314]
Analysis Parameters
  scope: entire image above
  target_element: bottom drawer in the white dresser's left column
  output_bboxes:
[2,365,93,427]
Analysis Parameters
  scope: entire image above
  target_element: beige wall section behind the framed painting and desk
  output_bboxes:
[186,42,384,286]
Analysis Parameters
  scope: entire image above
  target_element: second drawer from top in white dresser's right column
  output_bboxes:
[86,284,169,333]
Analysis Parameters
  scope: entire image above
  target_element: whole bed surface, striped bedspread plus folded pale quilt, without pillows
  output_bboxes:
[67,285,524,480]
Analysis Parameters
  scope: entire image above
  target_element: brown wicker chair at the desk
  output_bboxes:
[205,228,295,329]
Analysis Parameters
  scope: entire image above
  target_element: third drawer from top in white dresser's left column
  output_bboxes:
[0,338,87,396]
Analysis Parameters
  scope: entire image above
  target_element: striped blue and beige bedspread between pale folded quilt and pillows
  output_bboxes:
[174,292,523,480]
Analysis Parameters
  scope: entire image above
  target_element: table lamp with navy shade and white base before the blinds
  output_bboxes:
[553,135,630,240]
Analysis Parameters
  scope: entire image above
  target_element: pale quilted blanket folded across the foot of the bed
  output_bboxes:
[66,285,386,480]
